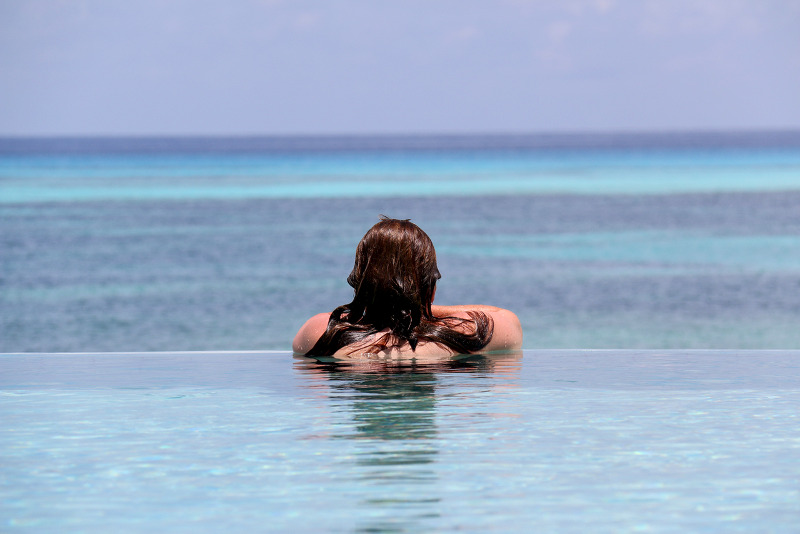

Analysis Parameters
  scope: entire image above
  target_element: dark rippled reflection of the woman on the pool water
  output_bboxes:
[298,351,521,532]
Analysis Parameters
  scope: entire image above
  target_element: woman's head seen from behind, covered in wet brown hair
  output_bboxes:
[347,217,441,337]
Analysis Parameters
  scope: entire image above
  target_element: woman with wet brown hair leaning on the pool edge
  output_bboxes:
[292,216,522,357]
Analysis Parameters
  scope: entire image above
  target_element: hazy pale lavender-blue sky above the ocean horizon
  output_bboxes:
[0,0,800,136]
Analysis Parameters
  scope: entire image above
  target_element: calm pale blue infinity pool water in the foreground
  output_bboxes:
[0,350,800,533]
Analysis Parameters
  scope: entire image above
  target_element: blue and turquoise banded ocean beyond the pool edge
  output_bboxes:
[0,132,800,353]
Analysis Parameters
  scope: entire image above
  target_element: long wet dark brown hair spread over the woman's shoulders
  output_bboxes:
[308,216,494,356]
